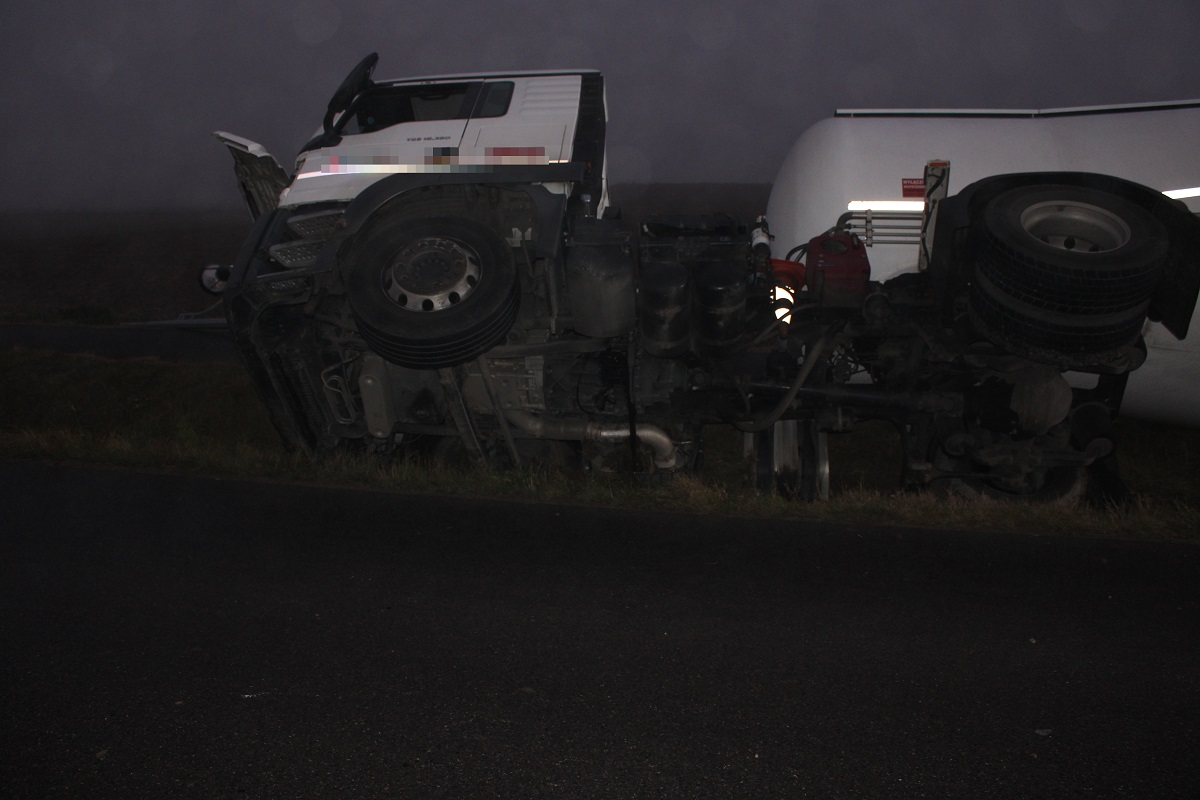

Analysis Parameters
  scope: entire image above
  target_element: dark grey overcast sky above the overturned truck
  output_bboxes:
[0,0,1200,211]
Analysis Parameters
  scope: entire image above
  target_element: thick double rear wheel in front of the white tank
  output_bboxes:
[968,185,1168,366]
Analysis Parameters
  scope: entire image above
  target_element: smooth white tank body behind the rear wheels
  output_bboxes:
[767,106,1200,426]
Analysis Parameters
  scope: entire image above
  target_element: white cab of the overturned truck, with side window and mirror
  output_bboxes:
[216,54,607,217]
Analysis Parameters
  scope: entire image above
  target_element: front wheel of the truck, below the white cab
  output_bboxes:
[342,217,521,369]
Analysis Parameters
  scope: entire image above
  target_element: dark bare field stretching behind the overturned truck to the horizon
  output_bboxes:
[0,184,769,324]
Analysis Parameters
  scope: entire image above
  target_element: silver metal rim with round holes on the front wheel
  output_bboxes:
[383,236,480,313]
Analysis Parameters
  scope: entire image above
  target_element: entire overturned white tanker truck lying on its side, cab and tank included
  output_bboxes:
[205,54,1200,498]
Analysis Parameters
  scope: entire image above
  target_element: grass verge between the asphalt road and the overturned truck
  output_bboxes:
[0,349,1200,541]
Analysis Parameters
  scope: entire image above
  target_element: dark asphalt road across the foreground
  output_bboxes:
[0,461,1200,799]
